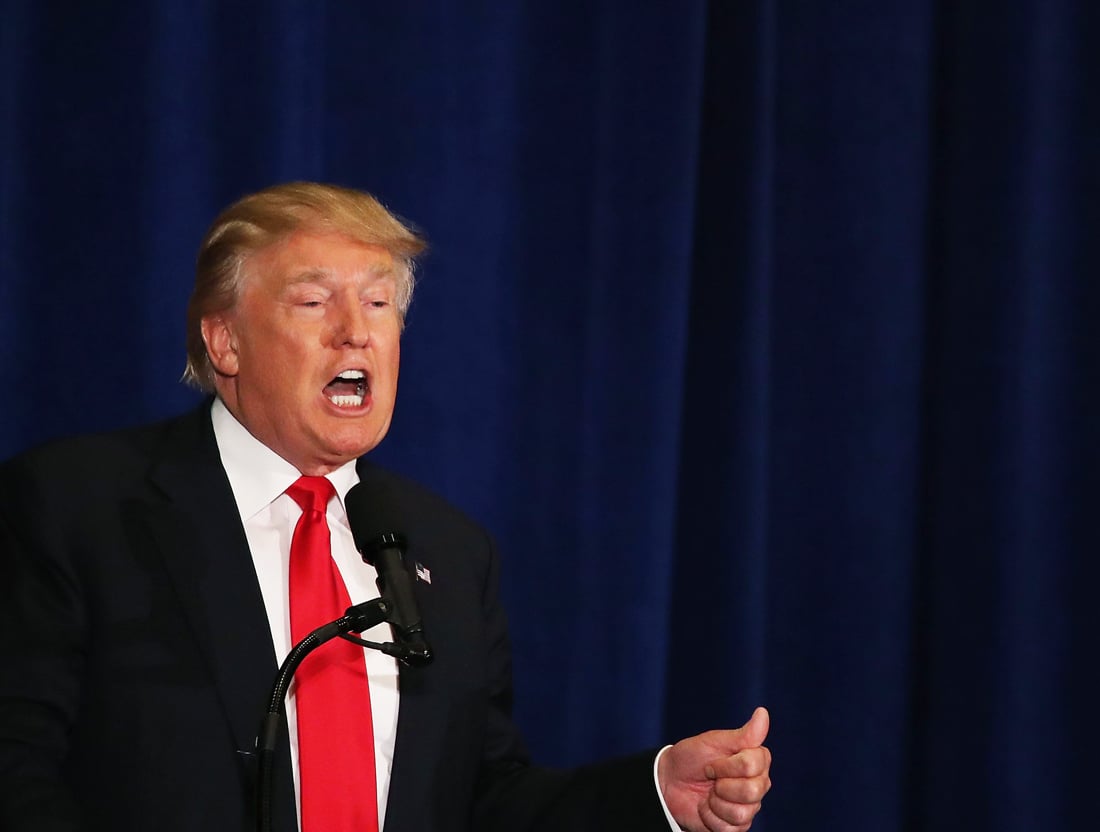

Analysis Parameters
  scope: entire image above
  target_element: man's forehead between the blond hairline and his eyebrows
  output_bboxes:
[244,231,398,288]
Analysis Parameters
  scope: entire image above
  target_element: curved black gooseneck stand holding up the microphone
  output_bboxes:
[256,598,416,832]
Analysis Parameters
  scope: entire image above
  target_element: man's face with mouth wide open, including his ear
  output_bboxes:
[202,231,402,475]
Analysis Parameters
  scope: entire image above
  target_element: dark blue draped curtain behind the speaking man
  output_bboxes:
[0,0,1100,832]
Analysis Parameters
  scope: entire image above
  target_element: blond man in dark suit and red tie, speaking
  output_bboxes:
[0,183,770,832]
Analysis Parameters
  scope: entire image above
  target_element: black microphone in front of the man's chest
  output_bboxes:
[344,482,432,667]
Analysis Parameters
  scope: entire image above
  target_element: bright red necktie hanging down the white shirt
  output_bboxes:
[286,477,378,832]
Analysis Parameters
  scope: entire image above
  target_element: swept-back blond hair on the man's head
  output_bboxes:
[184,182,427,392]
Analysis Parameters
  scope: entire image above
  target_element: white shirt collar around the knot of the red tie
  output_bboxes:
[210,398,359,522]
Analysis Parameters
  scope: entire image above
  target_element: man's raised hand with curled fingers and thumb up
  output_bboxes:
[657,708,771,832]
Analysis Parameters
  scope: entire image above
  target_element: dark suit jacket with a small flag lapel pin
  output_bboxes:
[0,405,668,832]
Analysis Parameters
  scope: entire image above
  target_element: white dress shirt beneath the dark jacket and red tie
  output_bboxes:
[210,398,398,830]
